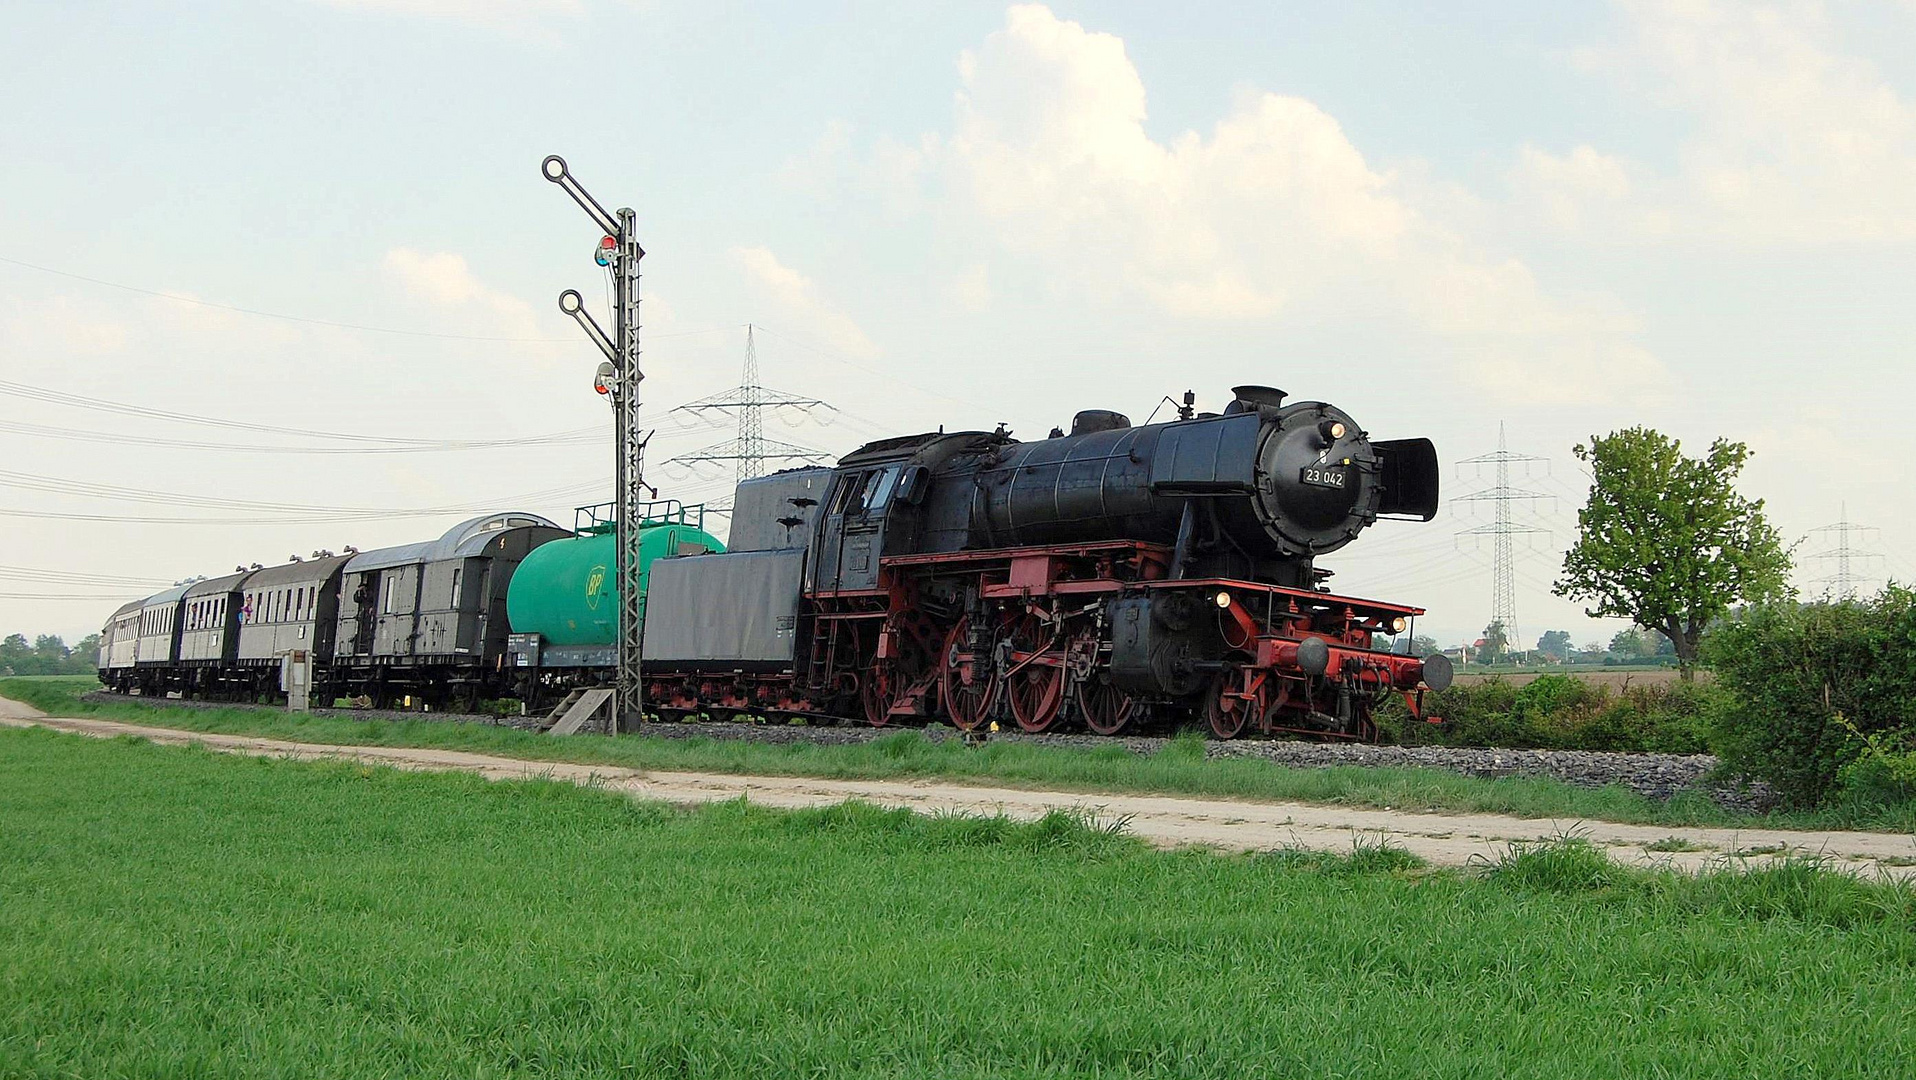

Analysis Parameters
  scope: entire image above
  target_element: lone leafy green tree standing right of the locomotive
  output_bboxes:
[1556,427,1790,680]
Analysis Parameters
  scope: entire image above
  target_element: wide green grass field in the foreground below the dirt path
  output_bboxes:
[0,730,1916,1078]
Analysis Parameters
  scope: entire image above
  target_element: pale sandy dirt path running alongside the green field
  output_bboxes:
[11,699,1916,877]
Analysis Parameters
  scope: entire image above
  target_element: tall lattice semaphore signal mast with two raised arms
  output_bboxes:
[538,153,651,733]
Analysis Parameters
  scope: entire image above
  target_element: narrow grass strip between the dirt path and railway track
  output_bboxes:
[0,678,1916,833]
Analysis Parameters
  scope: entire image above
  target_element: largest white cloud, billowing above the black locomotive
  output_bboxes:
[828,4,1663,400]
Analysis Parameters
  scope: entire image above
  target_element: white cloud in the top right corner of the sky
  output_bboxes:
[1512,0,1916,243]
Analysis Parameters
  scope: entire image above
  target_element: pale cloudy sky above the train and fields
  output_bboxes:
[0,0,1916,641]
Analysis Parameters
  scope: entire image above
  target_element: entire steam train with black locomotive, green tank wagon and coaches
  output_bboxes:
[102,387,1450,739]
